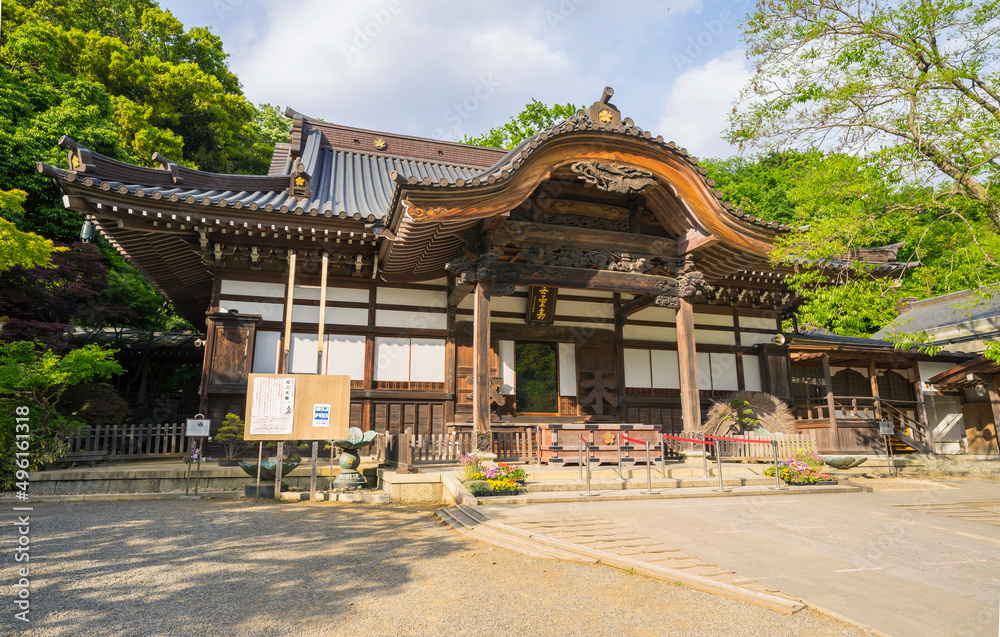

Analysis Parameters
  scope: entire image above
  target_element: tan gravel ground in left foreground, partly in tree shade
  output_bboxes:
[0,500,873,637]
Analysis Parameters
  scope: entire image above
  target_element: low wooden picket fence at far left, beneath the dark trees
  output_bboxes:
[63,423,192,462]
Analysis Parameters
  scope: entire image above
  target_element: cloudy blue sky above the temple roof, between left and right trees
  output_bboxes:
[161,0,753,157]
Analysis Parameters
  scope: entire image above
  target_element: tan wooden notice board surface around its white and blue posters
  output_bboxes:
[243,374,351,442]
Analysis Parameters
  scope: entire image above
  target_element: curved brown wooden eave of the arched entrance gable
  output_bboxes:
[380,124,784,278]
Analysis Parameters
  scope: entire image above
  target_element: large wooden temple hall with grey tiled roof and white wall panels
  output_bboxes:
[39,89,984,450]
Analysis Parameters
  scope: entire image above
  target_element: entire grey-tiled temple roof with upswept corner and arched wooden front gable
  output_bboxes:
[38,89,910,319]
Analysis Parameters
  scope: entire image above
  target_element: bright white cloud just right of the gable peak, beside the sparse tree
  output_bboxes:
[654,49,750,157]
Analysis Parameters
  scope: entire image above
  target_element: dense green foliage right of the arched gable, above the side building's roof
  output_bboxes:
[708,151,1000,336]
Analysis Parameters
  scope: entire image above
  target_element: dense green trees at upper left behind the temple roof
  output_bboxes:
[0,0,288,327]
